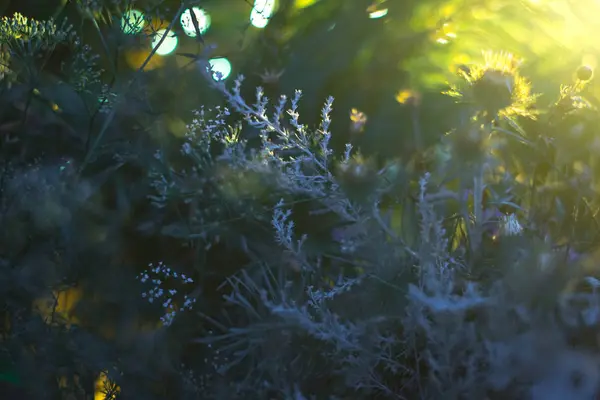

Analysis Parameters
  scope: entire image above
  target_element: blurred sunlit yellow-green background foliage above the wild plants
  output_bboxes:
[5,0,600,156]
